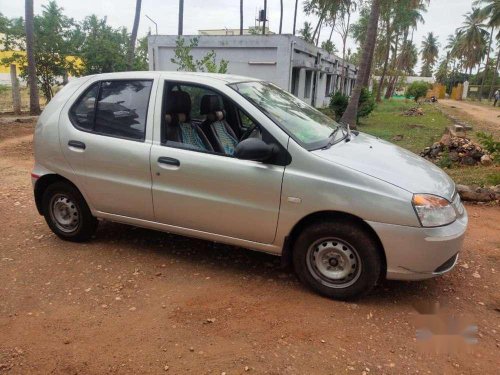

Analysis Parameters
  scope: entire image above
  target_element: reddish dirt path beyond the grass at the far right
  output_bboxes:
[439,99,500,135]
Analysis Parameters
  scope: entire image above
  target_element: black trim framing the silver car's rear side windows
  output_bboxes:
[68,78,154,143]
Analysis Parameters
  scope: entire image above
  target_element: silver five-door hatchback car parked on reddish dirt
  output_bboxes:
[31,72,467,299]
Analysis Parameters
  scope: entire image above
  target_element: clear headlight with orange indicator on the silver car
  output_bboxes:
[412,194,457,227]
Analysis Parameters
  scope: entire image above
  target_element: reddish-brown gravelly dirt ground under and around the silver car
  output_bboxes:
[0,119,500,375]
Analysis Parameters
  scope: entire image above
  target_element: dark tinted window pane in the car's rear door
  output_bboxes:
[94,80,153,140]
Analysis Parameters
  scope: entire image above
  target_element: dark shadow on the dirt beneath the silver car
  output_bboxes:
[92,221,446,305]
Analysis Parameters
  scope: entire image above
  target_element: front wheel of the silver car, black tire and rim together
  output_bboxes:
[293,220,383,300]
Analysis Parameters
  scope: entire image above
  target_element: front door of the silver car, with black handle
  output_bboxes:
[151,84,285,244]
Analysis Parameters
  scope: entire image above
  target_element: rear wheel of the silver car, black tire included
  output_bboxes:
[42,181,98,242]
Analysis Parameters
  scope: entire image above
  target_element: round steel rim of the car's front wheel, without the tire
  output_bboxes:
[306,237,362,288]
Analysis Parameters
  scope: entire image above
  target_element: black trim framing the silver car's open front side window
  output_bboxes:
[159,78,292,166]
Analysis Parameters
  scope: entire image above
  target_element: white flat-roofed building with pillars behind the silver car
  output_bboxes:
[148,35,357,107]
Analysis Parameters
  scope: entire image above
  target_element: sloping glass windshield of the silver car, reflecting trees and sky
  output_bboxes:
[230,81,339,150]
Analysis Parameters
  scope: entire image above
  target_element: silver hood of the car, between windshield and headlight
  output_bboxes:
[313,133,455,201]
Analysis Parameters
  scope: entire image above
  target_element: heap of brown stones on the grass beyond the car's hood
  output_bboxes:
[420,134,493,166]
